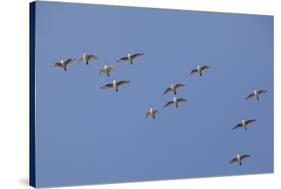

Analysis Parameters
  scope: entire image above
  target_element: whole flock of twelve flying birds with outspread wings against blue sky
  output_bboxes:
[50,52,267,166]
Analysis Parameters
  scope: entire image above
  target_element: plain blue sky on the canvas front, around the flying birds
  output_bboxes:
[32,2,273,186]
